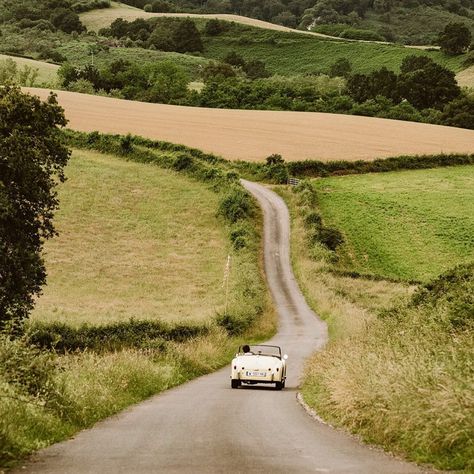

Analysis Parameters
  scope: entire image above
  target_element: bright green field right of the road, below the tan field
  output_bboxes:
[315,166,474,281]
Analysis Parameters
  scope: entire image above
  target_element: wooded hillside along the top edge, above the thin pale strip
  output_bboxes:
[118,0,474,44]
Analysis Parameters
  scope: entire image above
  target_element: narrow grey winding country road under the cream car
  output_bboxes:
[16,182,430,474]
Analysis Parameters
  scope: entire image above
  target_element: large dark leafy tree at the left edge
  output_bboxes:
[0,86,69,328]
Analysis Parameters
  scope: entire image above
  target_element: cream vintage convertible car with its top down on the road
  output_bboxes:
[230,345,288,390]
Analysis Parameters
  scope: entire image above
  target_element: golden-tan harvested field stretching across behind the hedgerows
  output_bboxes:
[25,88,474,161]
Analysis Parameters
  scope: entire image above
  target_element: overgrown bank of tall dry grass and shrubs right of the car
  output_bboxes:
[303,263,474,472]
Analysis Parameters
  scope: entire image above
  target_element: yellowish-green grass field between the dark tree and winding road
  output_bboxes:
[33,151,227,324]
